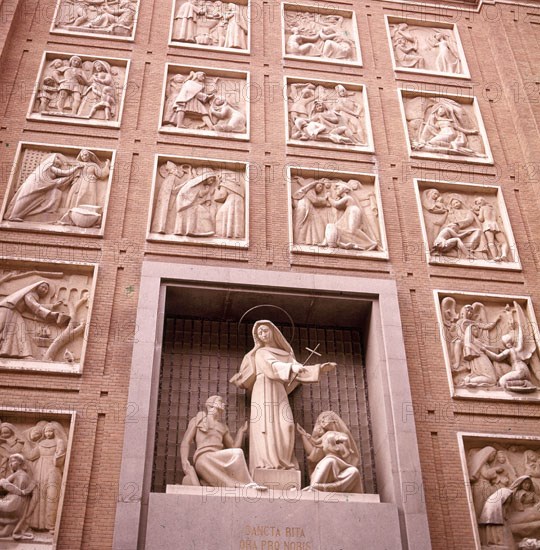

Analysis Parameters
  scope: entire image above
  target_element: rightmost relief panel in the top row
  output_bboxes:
[386,15,470,78]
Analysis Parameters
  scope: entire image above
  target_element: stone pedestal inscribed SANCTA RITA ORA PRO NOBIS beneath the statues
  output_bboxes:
[149,492,396,550]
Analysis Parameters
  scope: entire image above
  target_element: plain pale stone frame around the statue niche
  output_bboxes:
[113,261,431,550]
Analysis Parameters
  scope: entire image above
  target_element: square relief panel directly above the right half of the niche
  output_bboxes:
[289,167,388,259]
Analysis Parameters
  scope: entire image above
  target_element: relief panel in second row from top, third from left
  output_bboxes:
[285,77,373,152]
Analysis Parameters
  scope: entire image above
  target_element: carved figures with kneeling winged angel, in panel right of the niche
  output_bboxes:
[441,297,540,393]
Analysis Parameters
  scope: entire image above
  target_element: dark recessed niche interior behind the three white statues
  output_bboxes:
[151,286,377,494]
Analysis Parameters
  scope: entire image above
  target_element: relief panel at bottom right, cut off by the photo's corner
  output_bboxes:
[458,433,540,550]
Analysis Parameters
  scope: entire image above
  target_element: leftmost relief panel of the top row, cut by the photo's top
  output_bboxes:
[51,0,139,40]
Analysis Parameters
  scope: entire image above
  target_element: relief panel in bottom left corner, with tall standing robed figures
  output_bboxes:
[0,409,74,550]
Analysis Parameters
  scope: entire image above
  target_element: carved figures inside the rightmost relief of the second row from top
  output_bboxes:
[405,97,486,158]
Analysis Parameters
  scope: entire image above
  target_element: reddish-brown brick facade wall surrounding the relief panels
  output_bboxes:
[0,0,540,550]
